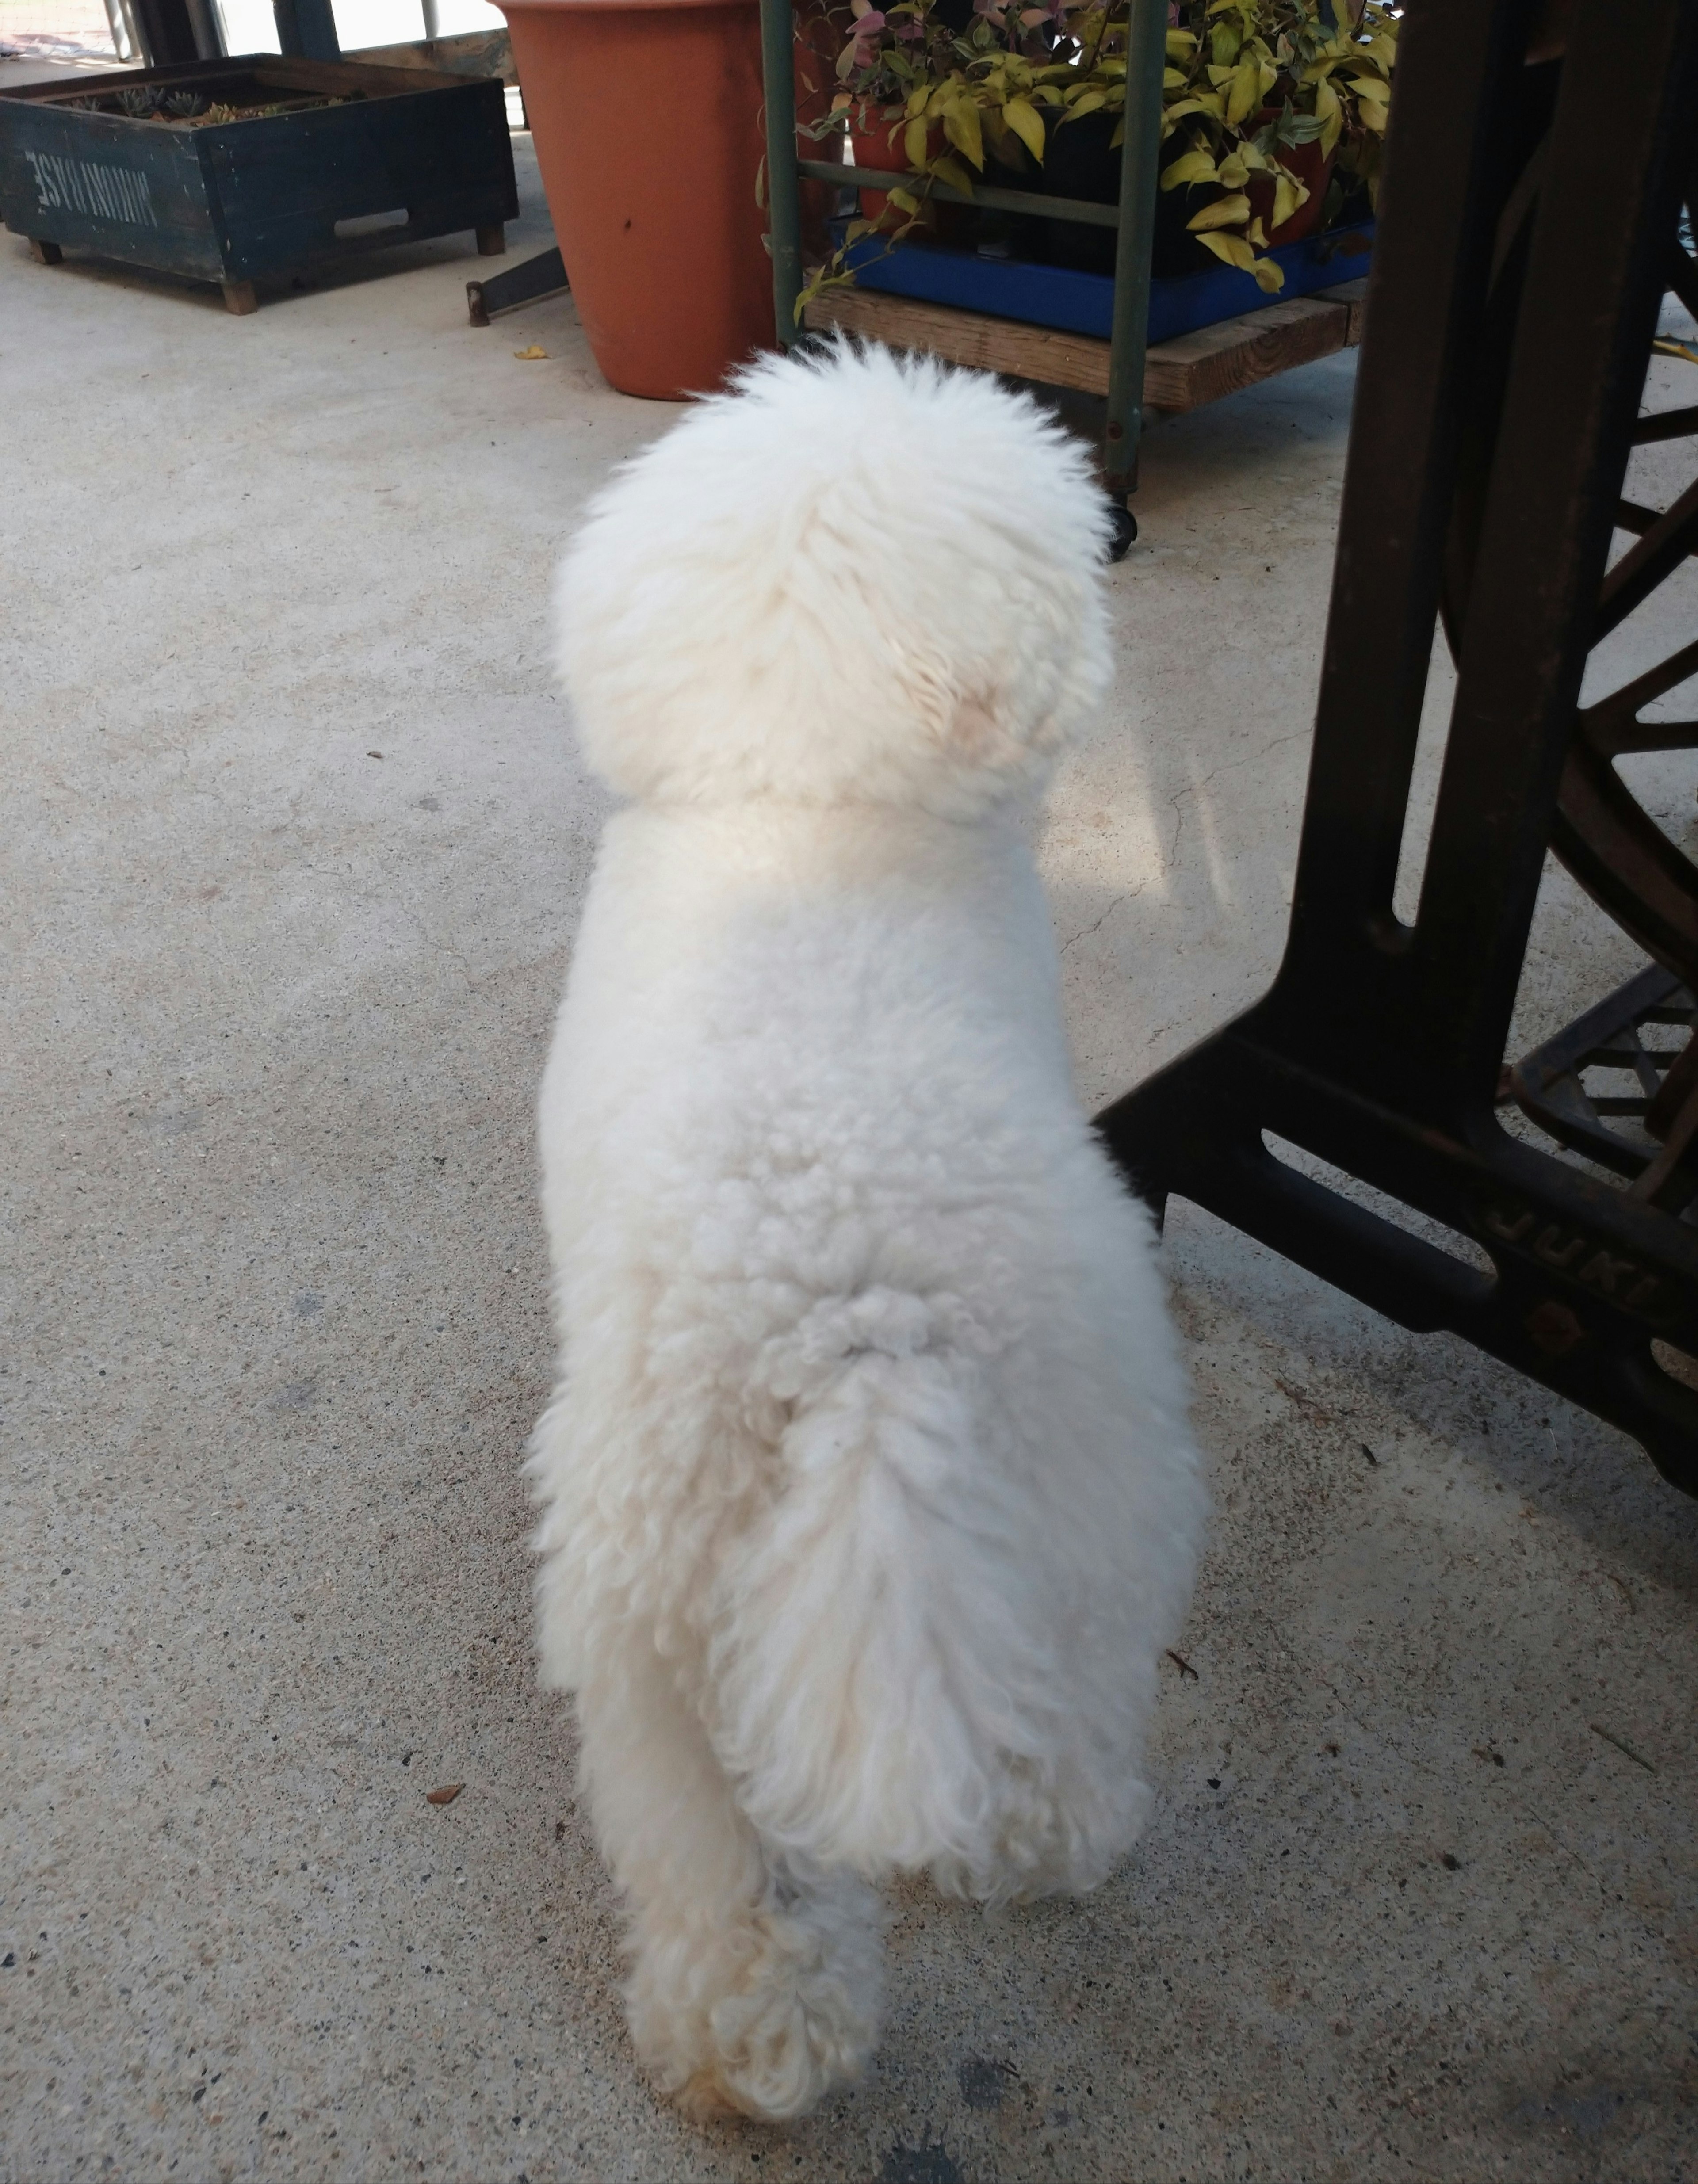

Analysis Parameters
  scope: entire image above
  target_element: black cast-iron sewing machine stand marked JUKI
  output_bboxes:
[1099,0,1698,1492]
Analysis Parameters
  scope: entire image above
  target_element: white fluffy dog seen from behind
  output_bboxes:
[531,347,1202,2119]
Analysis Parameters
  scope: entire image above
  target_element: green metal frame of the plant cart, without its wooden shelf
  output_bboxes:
[761,0,1167,502]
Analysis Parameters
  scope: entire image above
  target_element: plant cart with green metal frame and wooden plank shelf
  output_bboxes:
[761,0,1368,546]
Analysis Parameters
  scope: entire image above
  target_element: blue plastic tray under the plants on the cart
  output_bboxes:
[848,221,1375,345]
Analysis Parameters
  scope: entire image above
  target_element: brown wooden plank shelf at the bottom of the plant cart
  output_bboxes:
[807,282,1366,413]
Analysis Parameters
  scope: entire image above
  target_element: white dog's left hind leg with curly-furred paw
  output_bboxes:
[579,1629,879,2121]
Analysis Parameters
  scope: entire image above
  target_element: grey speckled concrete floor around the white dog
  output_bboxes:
[0,141,1698,2184]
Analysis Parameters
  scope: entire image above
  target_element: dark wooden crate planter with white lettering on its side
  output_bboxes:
[0,55,518,310]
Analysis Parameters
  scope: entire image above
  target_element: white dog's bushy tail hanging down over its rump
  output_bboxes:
[712,1299,1147,1898]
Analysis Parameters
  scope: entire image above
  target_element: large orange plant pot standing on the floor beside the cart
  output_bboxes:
[498,0,773,402]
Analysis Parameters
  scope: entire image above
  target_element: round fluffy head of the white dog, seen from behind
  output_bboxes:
[559,343,1108,815]
